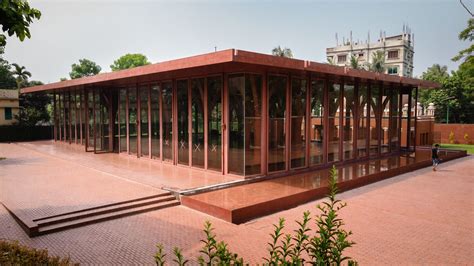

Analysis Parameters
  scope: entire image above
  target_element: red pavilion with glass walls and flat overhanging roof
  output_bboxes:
[22,49,438,178]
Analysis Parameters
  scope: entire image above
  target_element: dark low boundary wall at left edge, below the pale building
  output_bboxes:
[0,125,53,142]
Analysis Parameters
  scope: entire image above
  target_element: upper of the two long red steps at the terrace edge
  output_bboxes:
[35,195,176,227]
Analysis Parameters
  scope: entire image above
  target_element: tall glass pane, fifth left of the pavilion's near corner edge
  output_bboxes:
[161,82,173,161]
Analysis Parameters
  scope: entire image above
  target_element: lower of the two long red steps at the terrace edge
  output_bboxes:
[37,199,180,235]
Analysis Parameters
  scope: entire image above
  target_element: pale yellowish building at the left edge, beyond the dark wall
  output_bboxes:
[0,90,20,126]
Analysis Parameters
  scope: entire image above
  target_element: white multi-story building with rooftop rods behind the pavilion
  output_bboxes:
[326,27,415,77]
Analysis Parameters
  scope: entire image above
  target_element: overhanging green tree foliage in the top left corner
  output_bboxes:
[0,0,41,46]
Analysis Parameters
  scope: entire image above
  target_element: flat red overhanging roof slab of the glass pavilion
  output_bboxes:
[21,49,440,93]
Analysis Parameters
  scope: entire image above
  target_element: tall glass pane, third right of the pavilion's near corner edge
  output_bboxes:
[291,78,306,168]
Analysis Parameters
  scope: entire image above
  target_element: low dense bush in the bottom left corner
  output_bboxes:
[0,240,75,265]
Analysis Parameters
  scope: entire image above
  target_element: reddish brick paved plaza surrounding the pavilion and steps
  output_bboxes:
[0,142,474,264]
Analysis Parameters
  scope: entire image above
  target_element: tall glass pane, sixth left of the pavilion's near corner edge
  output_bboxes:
[150,85,160,158]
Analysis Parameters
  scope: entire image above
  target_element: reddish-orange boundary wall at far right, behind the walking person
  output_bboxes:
[433,124,474,144]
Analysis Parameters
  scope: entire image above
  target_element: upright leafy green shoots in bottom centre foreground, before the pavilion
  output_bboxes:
[155,166,357,266]
